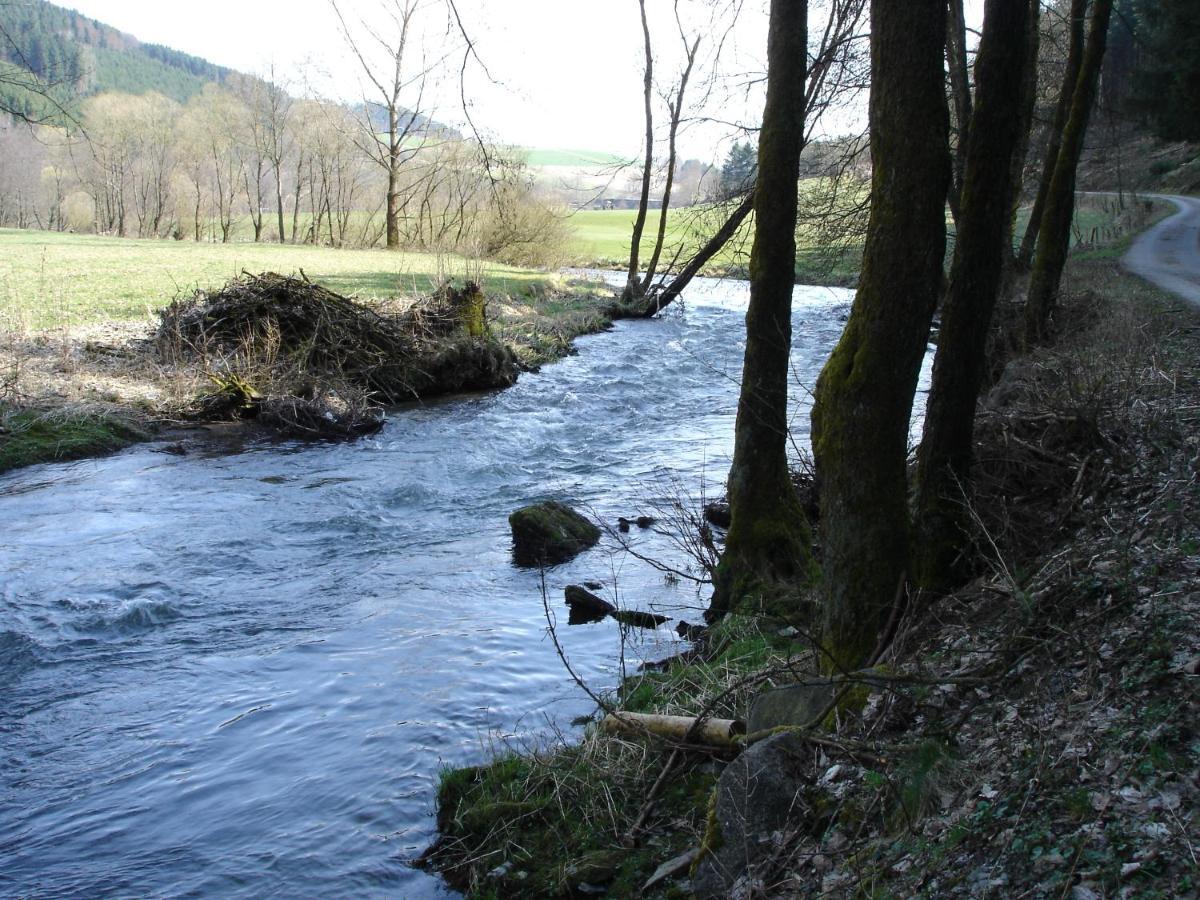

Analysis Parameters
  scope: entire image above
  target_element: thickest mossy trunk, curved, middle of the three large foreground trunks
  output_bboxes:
[812,0,950,666]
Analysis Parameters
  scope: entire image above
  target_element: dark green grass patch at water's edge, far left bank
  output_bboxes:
[0,407,149,473]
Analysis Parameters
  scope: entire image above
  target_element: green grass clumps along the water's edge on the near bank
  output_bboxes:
[426,617,800,896]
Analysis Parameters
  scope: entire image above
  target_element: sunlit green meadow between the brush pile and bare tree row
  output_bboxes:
[0,229,551,328]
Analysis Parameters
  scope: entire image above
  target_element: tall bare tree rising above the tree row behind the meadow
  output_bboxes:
[329,0,427,250]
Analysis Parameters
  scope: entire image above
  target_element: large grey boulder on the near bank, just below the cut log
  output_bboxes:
[691,733,812,898]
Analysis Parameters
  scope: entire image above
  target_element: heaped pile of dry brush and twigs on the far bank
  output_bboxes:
[156,272,517,437]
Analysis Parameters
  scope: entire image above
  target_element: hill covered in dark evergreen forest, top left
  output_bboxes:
[0,0,232,112]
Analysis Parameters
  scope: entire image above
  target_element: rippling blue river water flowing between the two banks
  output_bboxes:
[0,282,916,898]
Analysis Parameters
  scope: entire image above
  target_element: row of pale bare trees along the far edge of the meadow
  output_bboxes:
[0,77,560,262]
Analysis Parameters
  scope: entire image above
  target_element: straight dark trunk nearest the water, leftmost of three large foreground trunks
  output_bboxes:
[709,0,812,618]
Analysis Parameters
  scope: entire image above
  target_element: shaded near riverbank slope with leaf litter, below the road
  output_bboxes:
[426,253,1200,896]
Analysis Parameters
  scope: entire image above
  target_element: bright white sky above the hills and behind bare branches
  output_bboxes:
[59,0,984,160]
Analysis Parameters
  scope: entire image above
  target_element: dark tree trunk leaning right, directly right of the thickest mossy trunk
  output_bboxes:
[910,0,1030,590]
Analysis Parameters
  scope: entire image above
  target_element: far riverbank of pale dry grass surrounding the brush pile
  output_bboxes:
[0,276,618,473]
